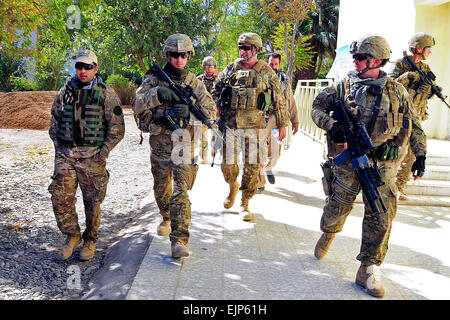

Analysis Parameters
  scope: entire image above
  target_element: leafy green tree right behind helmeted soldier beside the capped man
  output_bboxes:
[90,0,211,73]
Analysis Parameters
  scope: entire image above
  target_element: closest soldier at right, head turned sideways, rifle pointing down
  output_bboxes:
[312,35,426,297]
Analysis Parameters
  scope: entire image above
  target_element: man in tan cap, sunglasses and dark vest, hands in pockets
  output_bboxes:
[49,50,125,261]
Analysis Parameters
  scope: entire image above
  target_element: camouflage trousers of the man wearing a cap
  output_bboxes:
[48,153,109,241]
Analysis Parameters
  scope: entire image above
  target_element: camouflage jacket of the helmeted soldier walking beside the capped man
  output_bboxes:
[132,72,217,135]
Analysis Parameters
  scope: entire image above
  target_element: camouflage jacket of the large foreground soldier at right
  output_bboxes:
[311,77,426,157]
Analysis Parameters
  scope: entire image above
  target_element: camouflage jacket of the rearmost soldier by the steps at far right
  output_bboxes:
[391,58,431,121]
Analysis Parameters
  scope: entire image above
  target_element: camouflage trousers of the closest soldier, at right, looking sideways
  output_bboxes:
[320,161,397,266]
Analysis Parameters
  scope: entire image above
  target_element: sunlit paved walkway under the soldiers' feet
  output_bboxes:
[84,133,450,300]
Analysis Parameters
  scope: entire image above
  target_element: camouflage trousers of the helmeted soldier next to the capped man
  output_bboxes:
[150,129,198,244]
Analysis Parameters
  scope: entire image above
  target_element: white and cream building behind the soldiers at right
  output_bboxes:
[337,0,450,140]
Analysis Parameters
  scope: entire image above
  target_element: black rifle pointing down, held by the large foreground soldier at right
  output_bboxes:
[331,100,387,213]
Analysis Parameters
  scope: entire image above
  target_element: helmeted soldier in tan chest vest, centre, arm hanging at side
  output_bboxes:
[213,33,288,221]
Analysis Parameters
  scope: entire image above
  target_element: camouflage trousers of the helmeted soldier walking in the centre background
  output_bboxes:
[221,129,267,200]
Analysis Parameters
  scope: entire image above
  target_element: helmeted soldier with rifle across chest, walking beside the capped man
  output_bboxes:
[132,33,217,258]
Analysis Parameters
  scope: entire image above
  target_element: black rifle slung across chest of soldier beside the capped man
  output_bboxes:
[149,63,223,165]
